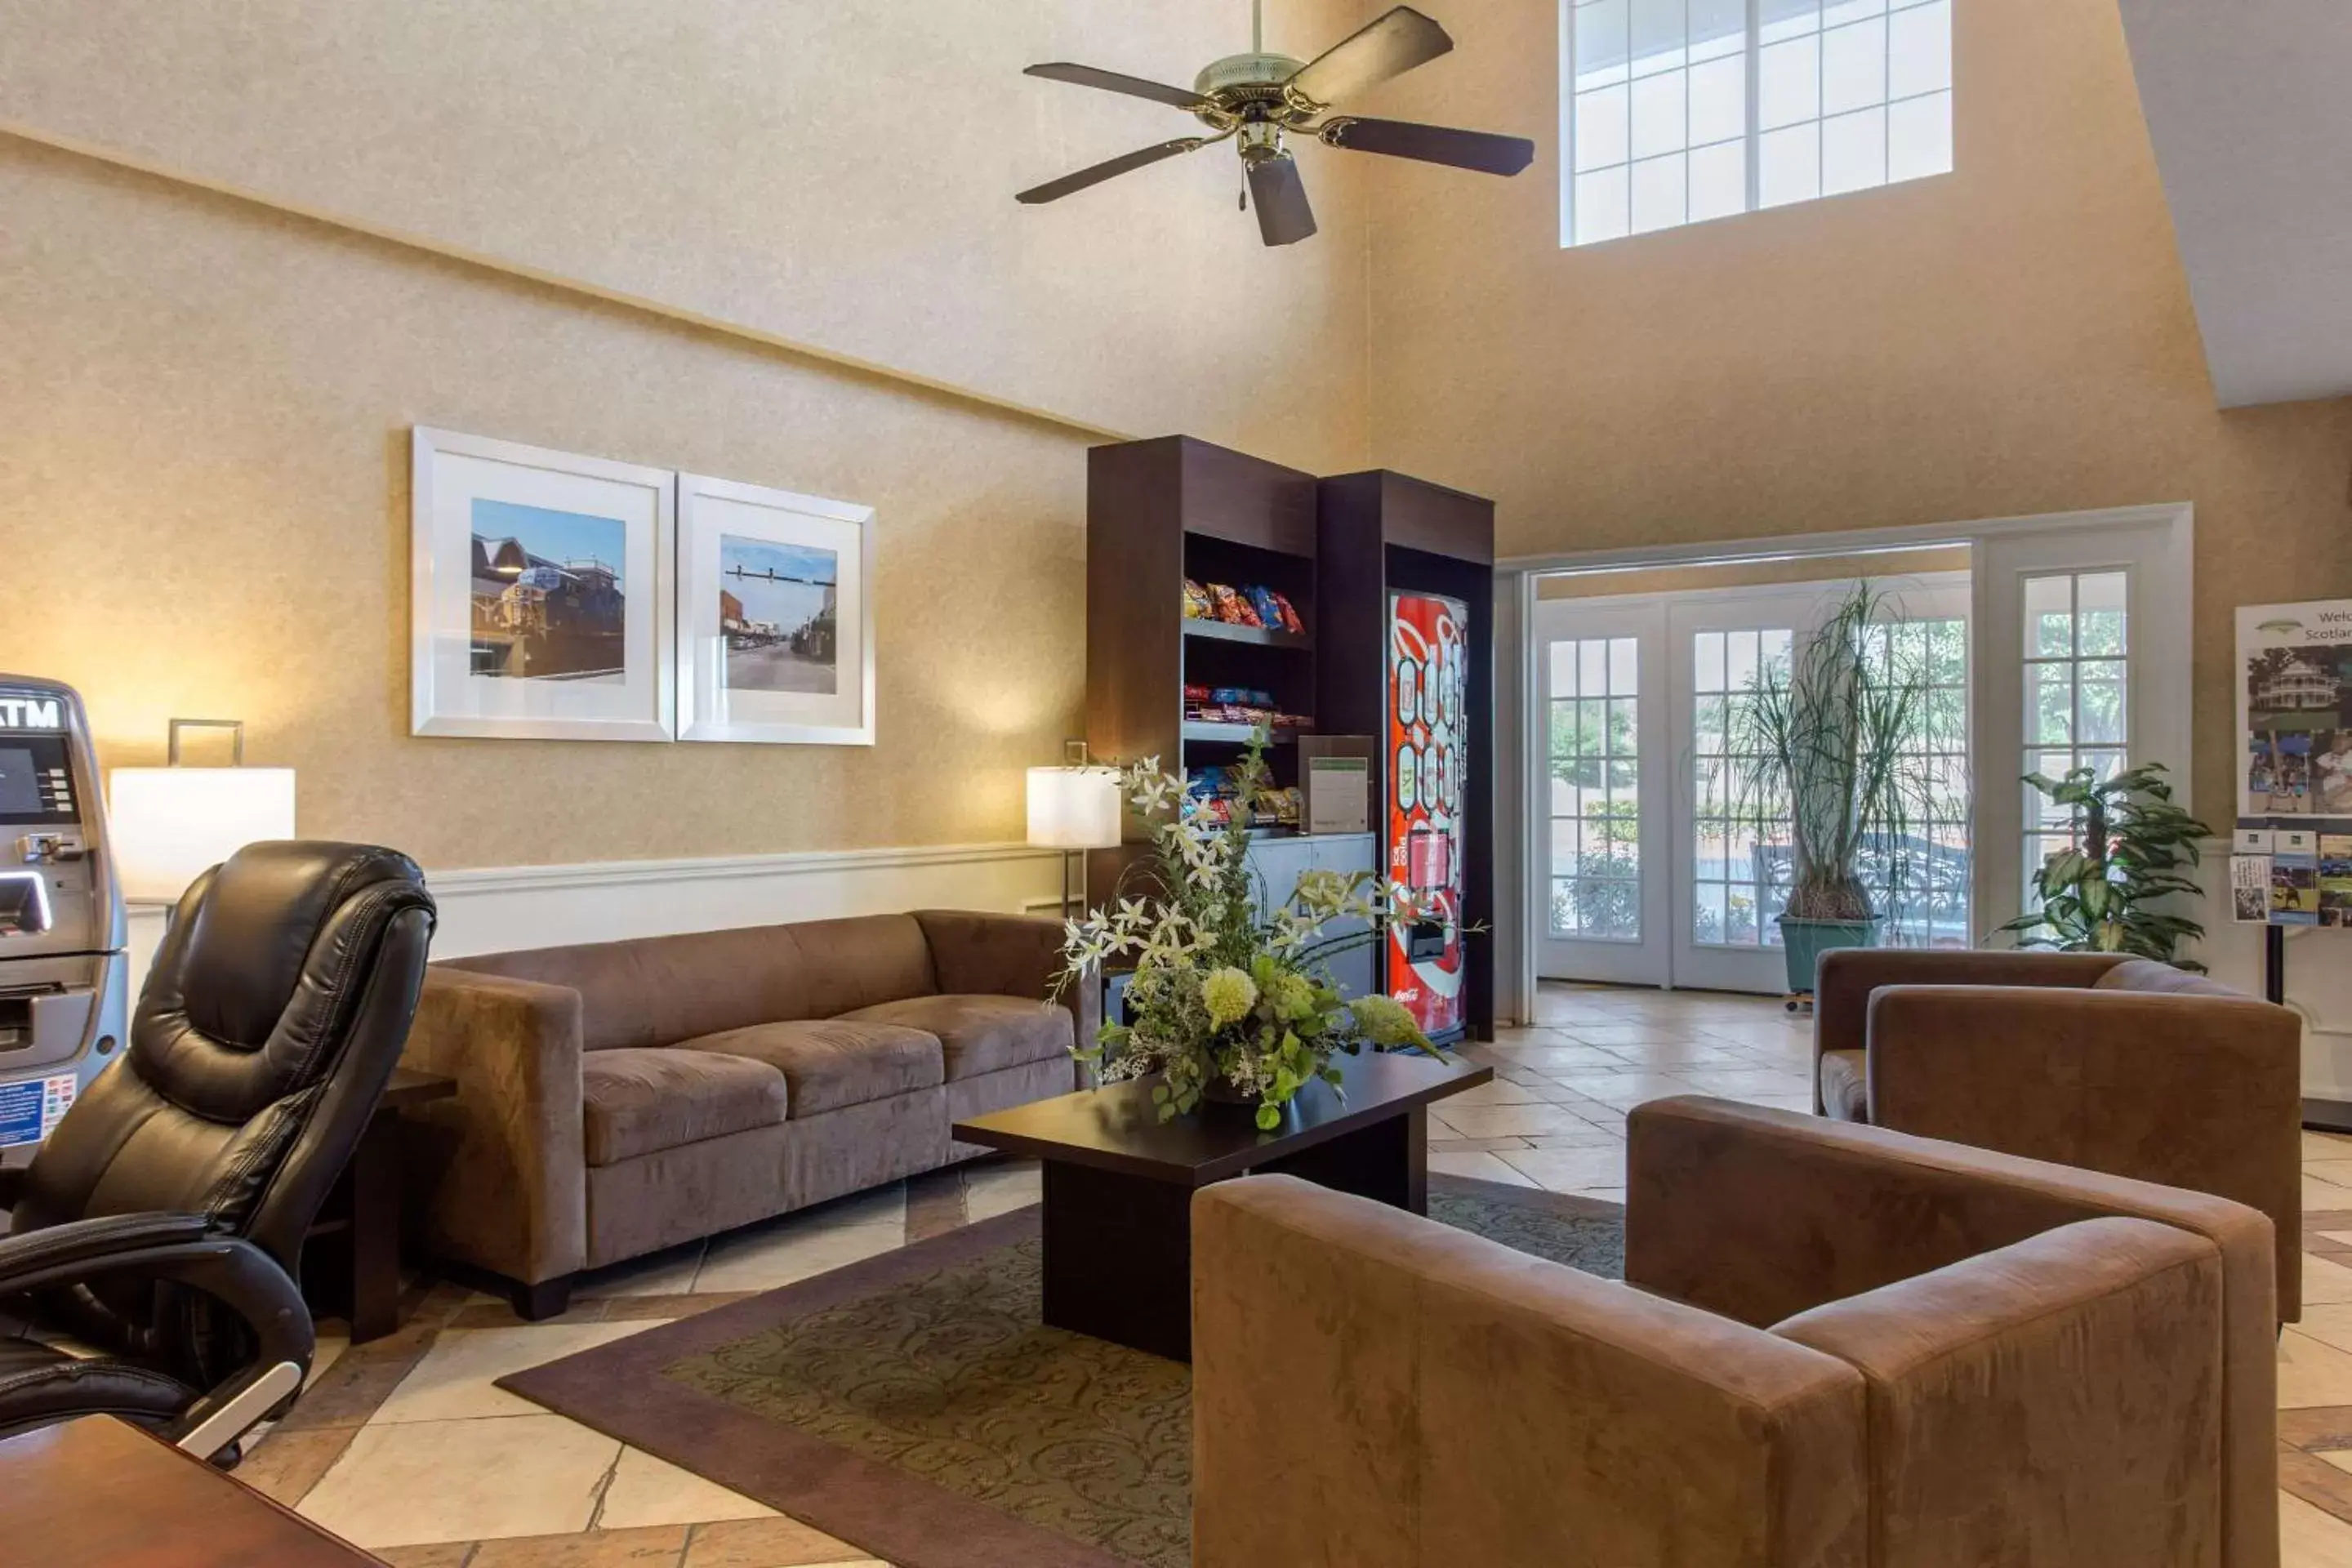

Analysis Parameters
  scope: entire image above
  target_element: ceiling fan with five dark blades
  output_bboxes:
[1013,0,1536,244]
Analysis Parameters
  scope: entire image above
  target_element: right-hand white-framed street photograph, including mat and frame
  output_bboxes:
[677,474,875,746]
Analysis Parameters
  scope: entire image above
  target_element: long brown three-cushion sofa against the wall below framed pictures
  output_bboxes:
[402,910,1096,1316]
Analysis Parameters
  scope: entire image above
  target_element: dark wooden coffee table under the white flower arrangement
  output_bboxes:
[955,1054,1494,1361]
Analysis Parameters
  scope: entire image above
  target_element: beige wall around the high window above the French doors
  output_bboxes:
[1371,0,2352,818]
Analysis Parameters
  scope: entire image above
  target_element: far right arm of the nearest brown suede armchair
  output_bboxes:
[1625,1098,2279,1563]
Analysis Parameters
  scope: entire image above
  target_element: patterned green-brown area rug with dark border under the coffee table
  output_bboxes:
[501,1175,1623,1568]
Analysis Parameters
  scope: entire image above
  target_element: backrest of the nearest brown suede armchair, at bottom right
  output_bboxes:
[1774,1220,2230,1568]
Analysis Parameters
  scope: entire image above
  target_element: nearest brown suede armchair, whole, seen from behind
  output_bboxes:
[1192,1098,2279,1568]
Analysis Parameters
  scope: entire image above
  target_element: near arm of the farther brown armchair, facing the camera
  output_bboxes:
[1868,985,2303,1321]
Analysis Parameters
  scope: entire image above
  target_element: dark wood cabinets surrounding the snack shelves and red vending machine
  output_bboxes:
[1087,435,1496,1039]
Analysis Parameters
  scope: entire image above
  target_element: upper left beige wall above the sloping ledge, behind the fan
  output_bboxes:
[0,0,1369,473]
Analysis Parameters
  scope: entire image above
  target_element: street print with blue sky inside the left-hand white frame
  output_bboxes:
[470,496,628,682]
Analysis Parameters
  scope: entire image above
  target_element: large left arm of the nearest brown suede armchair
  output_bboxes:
[1192,1175,1865,1568]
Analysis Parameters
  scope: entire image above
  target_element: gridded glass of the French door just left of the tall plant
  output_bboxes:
[1691,628,1793,947]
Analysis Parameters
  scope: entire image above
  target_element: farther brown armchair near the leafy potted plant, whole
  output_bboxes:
[1813,950,2303,1324]
